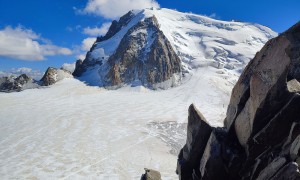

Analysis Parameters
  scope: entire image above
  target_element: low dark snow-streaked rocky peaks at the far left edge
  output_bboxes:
[0,74,38,92]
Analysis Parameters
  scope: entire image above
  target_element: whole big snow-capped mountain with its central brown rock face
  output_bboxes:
[74,8,277,88]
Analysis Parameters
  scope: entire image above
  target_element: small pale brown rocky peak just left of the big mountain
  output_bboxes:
[40,67,73,86]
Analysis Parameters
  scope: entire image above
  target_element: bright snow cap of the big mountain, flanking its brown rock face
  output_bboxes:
[85,8,277,74]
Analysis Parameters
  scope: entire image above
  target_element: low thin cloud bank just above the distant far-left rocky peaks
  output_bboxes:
[0,67,44,80]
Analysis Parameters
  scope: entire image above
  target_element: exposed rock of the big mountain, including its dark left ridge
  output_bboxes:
[73,12,181,89]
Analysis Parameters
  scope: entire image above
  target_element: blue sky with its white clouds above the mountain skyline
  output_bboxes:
[0,0,300,76]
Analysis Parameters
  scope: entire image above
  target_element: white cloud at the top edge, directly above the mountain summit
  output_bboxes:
[81,0,159,19]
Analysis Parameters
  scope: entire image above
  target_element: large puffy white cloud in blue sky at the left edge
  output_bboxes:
[0,26,72,61]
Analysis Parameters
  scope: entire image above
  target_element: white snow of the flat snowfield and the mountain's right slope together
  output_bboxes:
[0,9,276,180]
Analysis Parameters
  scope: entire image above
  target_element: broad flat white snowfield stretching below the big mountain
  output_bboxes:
[0,69,232,180]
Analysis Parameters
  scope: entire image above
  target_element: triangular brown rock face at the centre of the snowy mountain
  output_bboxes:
[104,17,181,87]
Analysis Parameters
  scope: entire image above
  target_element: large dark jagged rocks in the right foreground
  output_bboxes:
[177,22,300,180]
